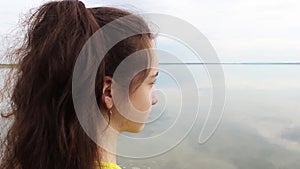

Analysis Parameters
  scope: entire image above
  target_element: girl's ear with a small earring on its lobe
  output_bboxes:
[102,76,113,109]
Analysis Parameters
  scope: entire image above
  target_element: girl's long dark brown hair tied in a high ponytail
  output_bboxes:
[0,1,153,169]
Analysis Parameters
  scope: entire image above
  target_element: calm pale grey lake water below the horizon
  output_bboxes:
[0,64,300,169]
